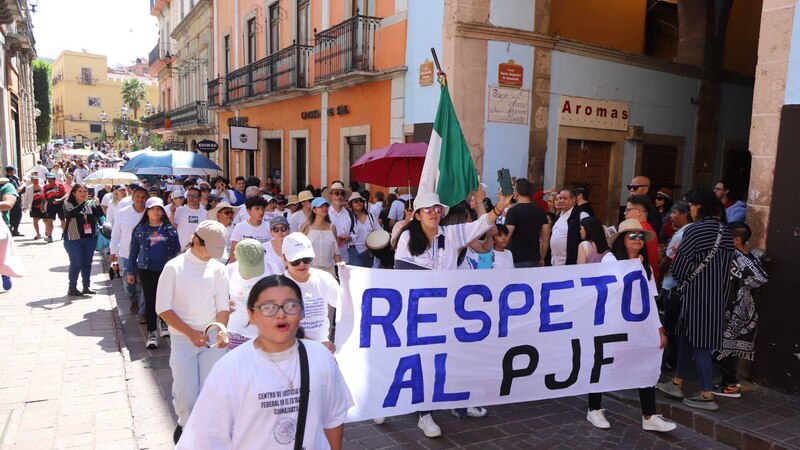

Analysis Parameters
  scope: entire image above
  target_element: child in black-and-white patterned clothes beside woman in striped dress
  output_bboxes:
[714,222,769,398]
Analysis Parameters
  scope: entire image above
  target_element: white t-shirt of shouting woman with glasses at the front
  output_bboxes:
[175,339,354,450]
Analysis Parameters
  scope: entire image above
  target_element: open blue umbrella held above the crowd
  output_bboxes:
[121,150,222,175]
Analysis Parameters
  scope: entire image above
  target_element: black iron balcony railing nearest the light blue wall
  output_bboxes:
[314,15,381,82]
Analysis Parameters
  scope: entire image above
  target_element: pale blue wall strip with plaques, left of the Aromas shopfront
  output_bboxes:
[482,41,534,195]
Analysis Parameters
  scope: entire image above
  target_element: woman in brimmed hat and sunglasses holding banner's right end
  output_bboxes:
[584,219,677,431]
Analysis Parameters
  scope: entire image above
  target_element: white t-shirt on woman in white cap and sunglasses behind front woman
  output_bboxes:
[284,267,342,342]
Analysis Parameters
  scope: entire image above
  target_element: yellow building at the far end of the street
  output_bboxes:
[52,51,158,141]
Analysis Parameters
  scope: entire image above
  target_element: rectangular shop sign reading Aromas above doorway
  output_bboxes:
[559,95,629,131]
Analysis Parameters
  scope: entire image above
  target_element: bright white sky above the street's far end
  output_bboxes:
[32,0,158,67]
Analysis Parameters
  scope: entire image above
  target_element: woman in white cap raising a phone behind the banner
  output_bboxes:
[395,188,511,437]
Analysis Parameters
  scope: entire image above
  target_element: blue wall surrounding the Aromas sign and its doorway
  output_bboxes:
[544,52,700,204]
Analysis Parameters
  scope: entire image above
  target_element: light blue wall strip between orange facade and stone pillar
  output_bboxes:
[404,1,444,124]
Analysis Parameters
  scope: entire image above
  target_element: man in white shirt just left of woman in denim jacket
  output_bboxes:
[108,186,147,316]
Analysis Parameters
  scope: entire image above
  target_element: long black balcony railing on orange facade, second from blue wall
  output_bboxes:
[225,44,311,104]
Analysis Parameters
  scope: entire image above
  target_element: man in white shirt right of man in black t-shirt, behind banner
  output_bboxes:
[550,188,589,266]
